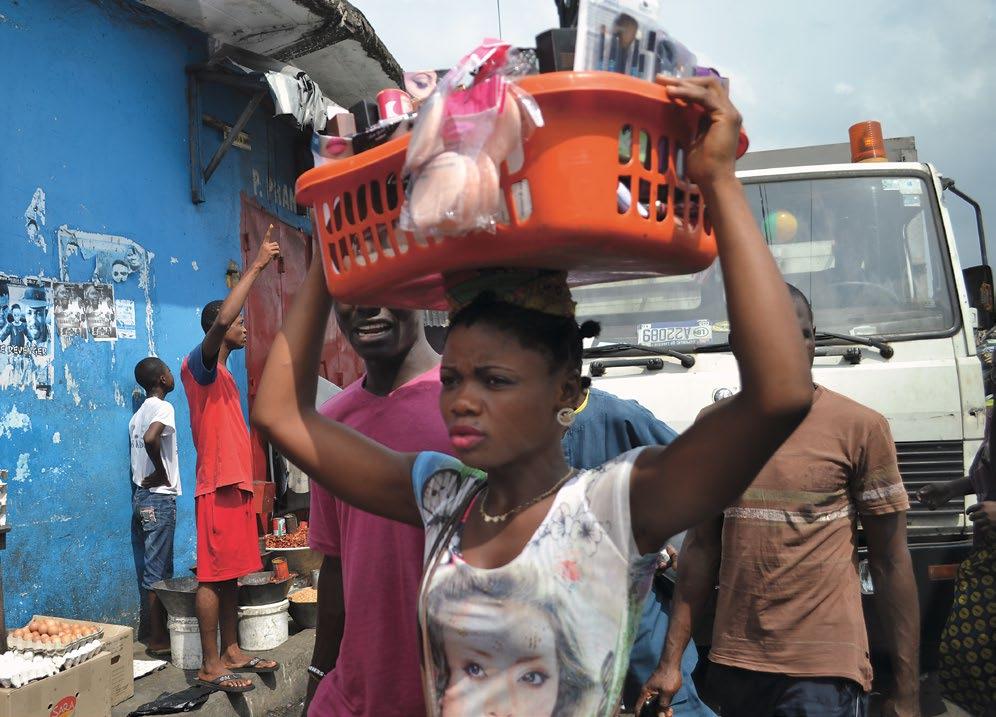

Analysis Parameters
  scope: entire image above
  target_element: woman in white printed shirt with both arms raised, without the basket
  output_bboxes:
[253,78,812,717]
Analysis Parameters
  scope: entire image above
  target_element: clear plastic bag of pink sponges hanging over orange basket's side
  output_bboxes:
[399,40,543,237]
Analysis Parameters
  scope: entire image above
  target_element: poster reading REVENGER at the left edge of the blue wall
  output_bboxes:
[0,275,55,398]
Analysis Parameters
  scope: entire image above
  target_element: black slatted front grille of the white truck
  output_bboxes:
[896,441,965,537]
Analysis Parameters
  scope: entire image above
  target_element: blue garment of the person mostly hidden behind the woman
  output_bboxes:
[563,388,715,717]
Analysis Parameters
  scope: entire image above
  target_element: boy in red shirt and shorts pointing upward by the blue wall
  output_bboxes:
[180,225,280,692]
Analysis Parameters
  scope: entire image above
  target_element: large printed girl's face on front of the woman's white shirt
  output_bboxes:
[441,597,559,717]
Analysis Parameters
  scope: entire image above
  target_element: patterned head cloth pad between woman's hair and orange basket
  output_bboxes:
[446,269,575,318]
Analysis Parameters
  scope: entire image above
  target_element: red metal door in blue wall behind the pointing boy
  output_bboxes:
[241,195,363,481]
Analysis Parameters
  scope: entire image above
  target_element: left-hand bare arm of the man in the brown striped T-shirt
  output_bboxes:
[636,515,723,717]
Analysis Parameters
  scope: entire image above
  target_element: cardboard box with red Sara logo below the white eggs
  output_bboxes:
[0,652,111,717]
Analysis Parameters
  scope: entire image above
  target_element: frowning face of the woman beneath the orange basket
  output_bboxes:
[439,324,580,470]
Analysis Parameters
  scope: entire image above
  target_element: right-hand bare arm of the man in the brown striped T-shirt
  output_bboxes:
[861,511,920,716]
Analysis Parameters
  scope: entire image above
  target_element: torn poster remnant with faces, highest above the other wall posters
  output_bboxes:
[58,225,148,287]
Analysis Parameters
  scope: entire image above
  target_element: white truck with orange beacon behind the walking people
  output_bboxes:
[574,137,992,670]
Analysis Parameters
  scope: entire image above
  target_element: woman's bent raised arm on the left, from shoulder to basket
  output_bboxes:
[252,252,422,526]
